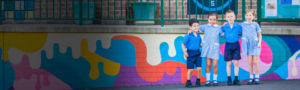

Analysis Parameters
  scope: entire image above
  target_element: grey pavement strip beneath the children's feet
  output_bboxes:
[79,80,300,90]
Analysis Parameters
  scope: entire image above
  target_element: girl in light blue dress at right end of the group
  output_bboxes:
[241,10,262,85]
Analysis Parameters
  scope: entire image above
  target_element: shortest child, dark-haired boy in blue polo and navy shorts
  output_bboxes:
[182,19,201,88]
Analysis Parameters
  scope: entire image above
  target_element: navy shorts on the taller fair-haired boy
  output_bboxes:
[224,42,241,61]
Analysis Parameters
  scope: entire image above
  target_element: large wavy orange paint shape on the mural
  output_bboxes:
[113,35,206,83]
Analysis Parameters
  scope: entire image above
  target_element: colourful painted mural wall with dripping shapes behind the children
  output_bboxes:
[0,33,300,90]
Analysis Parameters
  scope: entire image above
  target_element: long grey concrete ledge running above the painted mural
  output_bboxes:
[0,24,300,35]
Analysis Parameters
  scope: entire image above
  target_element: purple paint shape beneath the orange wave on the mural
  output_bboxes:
[113,65,183,87]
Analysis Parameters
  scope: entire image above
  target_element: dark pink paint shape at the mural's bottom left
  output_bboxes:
[12,55,71,90]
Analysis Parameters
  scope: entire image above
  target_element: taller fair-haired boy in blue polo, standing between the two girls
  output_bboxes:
[221,10,242,85]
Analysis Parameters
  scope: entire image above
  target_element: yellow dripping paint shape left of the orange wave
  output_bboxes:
[81,39,120,80]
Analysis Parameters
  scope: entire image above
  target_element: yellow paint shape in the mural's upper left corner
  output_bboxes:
[0,32,48,60]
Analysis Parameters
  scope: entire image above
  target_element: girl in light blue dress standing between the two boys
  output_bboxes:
[199,12,223,86]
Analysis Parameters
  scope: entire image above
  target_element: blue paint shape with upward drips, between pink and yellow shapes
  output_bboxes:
[40,44,118,89]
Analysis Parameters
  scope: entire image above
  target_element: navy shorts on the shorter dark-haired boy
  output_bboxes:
[186,50,201,69]
